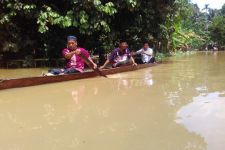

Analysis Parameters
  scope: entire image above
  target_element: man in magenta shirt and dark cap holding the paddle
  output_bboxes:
[46,36,97,75]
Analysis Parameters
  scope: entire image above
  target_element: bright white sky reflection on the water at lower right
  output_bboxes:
[176,91,225,150]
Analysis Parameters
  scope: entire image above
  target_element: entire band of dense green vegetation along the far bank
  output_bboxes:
[0,0,225,58]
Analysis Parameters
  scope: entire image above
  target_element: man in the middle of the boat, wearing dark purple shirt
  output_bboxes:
[100,40,137,69]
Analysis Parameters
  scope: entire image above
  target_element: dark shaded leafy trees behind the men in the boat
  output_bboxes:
[0,0,174,55]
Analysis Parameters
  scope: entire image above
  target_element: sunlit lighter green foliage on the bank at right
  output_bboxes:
[159,0,225,51]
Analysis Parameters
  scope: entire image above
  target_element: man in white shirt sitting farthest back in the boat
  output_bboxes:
[133,42,155,64]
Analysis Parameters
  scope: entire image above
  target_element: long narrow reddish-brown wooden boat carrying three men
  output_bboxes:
[0,64,157,90]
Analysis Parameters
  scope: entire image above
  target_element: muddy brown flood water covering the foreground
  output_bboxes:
[0,52,225,150]
